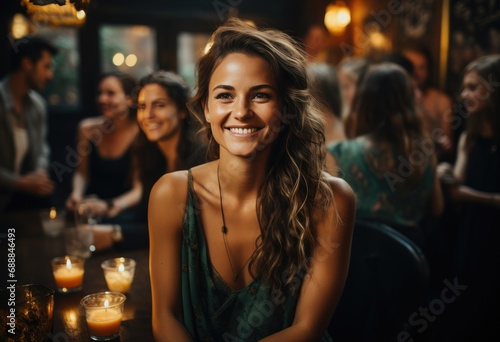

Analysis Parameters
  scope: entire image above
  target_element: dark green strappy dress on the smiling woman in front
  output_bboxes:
[182,170,334,341]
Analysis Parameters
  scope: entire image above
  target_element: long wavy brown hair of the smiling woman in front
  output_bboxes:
[188,18,333,288]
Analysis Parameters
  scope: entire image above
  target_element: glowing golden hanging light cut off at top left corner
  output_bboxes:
[21,0,90,26]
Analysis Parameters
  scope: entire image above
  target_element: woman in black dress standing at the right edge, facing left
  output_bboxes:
[438,55,500,341]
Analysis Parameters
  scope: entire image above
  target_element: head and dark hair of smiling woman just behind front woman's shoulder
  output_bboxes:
[135,70,206,195]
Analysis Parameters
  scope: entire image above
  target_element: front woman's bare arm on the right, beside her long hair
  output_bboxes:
[263,177,355,341]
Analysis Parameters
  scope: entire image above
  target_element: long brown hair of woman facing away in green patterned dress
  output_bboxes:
[351,62,431,188]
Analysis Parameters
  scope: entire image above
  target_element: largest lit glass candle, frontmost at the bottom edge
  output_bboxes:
[80,291,126,341]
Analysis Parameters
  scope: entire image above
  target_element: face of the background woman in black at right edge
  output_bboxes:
[460,71,492,113]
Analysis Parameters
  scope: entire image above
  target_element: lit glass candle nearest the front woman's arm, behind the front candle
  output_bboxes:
[101,258,135,293]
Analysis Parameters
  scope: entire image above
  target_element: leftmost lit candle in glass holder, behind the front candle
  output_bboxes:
[51,255,85,293]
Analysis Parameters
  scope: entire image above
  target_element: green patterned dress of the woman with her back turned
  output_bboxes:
[327,137,433,228]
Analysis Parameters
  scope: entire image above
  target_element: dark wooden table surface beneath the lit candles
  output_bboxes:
[0,212,154,342]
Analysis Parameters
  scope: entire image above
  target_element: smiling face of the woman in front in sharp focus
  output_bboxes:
[205,53,281,157]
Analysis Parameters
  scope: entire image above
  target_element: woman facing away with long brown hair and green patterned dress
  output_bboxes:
[327,63,443,246]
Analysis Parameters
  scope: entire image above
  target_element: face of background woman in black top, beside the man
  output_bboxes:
[97,76,131,119]
